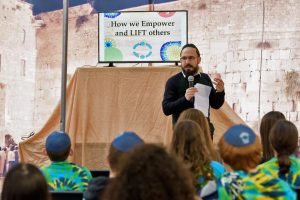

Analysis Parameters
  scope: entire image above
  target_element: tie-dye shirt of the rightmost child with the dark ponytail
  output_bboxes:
[258,156,300,189]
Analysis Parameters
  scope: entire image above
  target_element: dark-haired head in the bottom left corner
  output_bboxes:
[1,163,51,200]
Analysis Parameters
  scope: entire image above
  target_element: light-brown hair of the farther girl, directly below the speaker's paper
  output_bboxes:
[177,108,222,161]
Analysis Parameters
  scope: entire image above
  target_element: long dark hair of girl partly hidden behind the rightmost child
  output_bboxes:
[260,111,285,163]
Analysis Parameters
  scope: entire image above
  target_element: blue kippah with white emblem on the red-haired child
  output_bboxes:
[224,124,256,147]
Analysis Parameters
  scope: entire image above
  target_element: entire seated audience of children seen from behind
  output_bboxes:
[1,109,300,200]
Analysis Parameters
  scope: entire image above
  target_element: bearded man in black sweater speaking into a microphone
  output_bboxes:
[162,44,225,138]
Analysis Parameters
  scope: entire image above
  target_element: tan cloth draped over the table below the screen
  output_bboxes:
[19,67,243,169]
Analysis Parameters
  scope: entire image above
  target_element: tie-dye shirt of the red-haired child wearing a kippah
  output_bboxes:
[201,170,297,200]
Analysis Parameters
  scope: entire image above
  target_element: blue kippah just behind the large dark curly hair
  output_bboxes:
[112,131,144,152]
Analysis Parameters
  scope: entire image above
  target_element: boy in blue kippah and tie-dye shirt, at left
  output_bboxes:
[41,131,92,191]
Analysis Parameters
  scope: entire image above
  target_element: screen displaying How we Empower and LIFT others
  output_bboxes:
[98,11,187,63]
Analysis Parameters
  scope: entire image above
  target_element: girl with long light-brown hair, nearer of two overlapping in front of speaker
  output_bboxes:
[170,120,225,193]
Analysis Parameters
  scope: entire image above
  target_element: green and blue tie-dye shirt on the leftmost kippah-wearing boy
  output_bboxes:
[41,161,92,191]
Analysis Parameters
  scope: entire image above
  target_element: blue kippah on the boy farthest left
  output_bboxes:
[45,131,71,153]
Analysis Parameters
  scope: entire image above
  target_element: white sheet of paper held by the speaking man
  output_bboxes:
[194,83,211,117]
